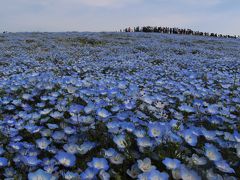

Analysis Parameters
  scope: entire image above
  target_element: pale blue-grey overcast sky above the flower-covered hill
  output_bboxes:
[0,0,240,35]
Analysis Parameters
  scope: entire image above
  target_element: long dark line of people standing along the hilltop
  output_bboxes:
[123,26,240,38]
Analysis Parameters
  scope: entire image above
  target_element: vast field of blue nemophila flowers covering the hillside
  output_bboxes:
[0,33,240,180]
